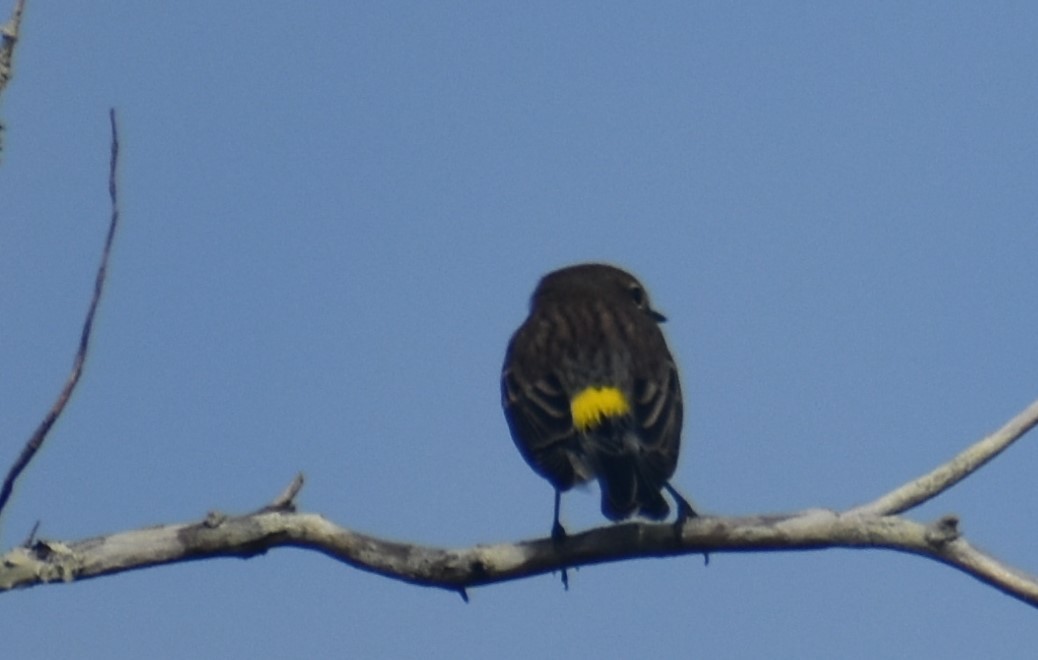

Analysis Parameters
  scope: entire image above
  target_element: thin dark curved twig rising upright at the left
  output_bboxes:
[0,108,119,525]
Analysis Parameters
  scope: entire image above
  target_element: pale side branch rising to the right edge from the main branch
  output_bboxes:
[847,402,1038,516]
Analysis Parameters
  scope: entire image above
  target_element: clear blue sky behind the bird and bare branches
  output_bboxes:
[0,0,1038,659]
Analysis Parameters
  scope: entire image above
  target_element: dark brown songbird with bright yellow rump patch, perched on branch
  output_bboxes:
[501,264,696,541]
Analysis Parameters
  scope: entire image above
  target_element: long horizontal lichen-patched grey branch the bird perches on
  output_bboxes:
[0,471,1038,606]
